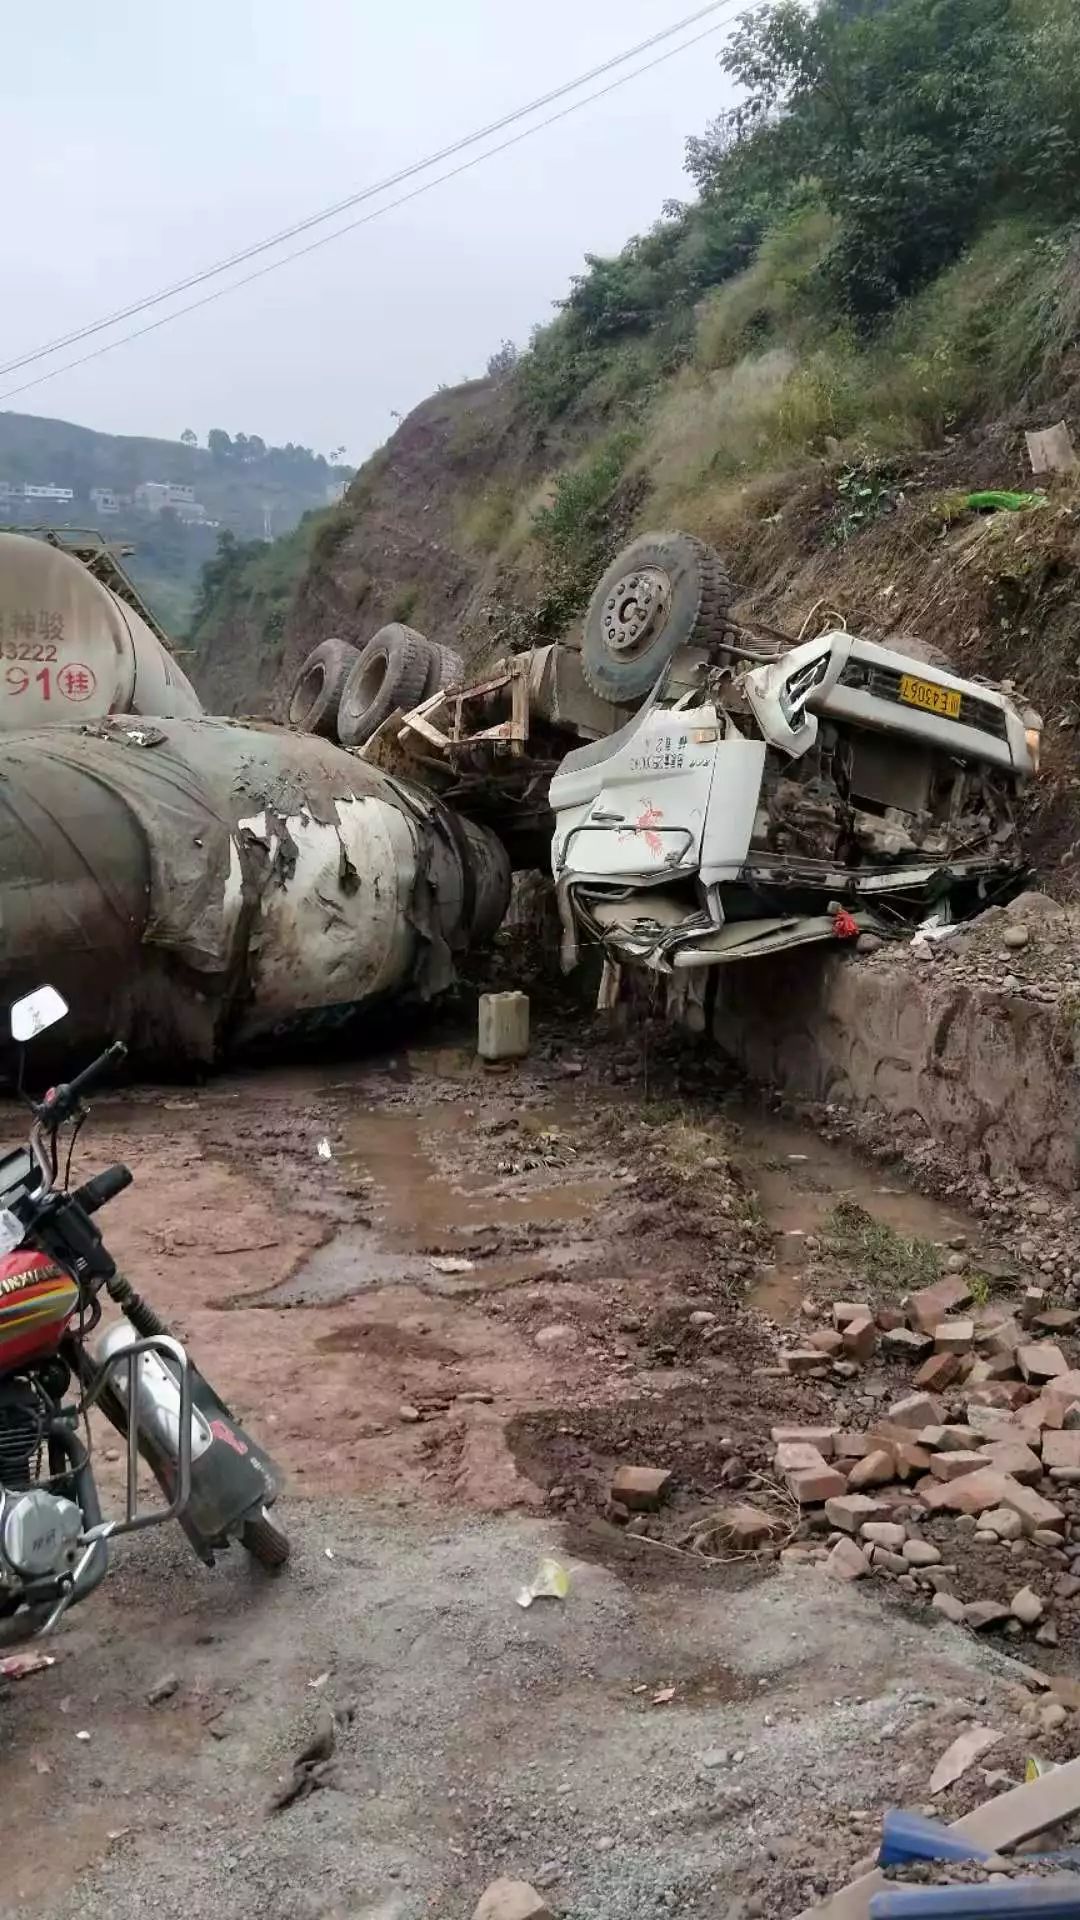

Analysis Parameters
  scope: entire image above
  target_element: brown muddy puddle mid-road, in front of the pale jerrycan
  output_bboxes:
[265,1102,613,1306]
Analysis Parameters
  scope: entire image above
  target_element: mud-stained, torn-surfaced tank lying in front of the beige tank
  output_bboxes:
[0,718,509,1066]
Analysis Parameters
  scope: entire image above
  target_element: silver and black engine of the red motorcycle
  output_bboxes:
[0,1380,83,1590]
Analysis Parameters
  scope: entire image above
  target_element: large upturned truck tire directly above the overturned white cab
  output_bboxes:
[580,534,734,705]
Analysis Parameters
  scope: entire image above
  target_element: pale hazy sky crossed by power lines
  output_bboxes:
[0,0,730,461]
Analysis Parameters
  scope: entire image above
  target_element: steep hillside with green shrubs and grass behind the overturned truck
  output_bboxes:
[194,0,1080,883]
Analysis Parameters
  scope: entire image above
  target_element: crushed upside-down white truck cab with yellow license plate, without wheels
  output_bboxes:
[550,632,1038,970]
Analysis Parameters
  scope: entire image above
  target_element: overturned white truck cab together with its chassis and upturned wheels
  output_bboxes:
[295,534,1042,975]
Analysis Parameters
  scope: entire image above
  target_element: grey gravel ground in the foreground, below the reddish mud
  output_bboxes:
[0,1501,1045,1920]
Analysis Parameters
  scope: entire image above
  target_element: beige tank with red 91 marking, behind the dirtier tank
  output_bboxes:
[0,534,202,733]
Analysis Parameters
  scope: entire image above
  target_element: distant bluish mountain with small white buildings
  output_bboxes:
[0,413,352,636]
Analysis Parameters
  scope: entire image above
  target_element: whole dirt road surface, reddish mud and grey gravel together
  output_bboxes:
[0,1029,1060,1920]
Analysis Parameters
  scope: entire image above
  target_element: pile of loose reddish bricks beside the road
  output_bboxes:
[773,1273,1080,1644]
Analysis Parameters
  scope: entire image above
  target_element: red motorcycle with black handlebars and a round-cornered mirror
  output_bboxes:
[0,987,288,1647]
